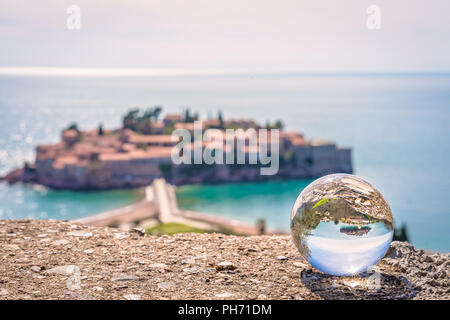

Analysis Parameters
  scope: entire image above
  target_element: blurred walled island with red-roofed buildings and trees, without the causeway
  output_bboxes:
[3,106,352,190]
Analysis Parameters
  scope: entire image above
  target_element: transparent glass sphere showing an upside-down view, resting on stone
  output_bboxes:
[291,174,394,276]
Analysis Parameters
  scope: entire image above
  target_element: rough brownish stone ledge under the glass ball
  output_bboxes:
[0,220,450,299]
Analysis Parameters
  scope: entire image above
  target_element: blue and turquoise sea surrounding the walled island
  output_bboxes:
[0,74,450,251]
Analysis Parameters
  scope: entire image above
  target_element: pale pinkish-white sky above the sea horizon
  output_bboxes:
[0,0,450,72]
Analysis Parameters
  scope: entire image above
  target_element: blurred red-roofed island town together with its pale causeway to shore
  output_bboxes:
[3,106,352,235]
